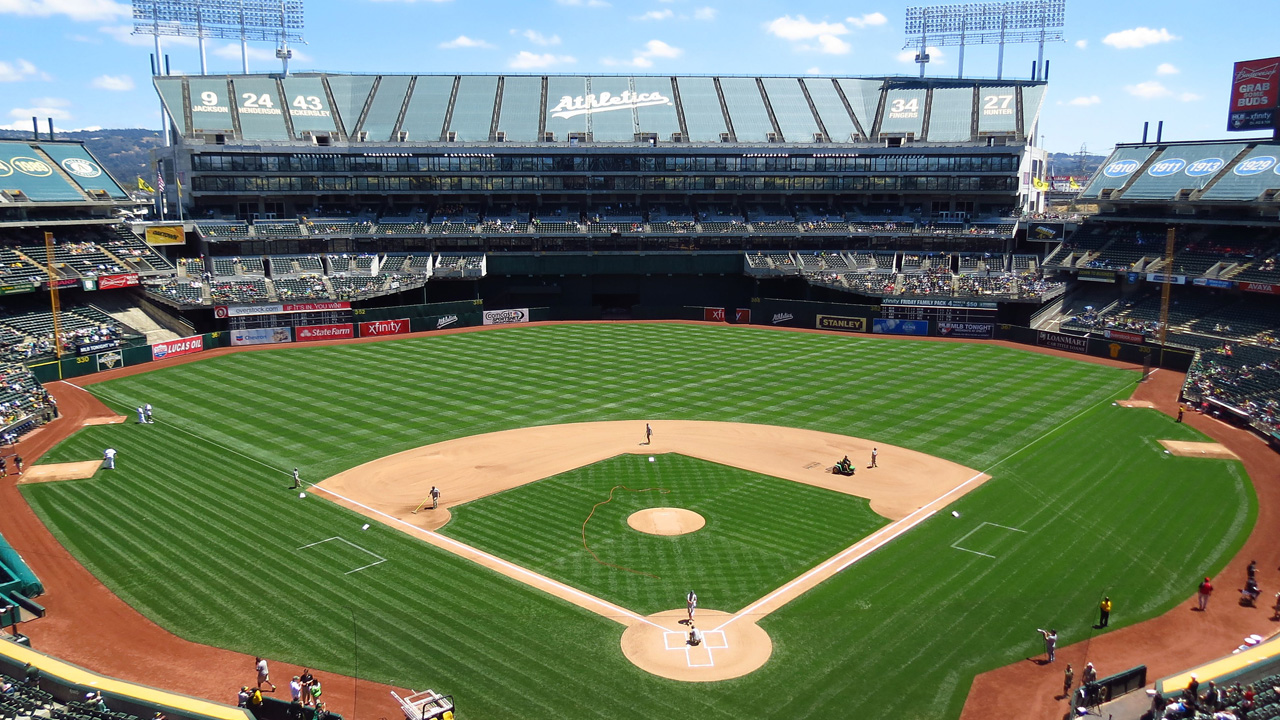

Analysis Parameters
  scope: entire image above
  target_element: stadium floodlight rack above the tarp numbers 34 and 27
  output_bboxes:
[902,0,1066,78]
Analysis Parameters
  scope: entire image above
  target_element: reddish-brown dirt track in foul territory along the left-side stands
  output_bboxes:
[0,381,403,719]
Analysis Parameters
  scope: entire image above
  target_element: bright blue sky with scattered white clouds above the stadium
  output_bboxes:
[0,0,1280,154]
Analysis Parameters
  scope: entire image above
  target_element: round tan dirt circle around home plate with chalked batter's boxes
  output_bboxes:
[622,609,773,683]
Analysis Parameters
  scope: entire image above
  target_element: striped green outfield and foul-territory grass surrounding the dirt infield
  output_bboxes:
[23,324,1256,720]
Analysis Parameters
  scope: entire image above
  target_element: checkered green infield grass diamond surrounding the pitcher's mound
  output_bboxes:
[443,454,887,615]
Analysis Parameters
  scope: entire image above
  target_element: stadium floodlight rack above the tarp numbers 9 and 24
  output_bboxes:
[133,0,305,74]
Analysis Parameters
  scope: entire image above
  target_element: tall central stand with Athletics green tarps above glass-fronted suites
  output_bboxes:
[155,74,1046,219]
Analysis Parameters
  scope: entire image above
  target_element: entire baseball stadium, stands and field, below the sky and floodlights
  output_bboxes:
[0,12,1280,720]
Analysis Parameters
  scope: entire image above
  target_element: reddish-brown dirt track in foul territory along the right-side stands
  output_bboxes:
[960,370,1280,720]
